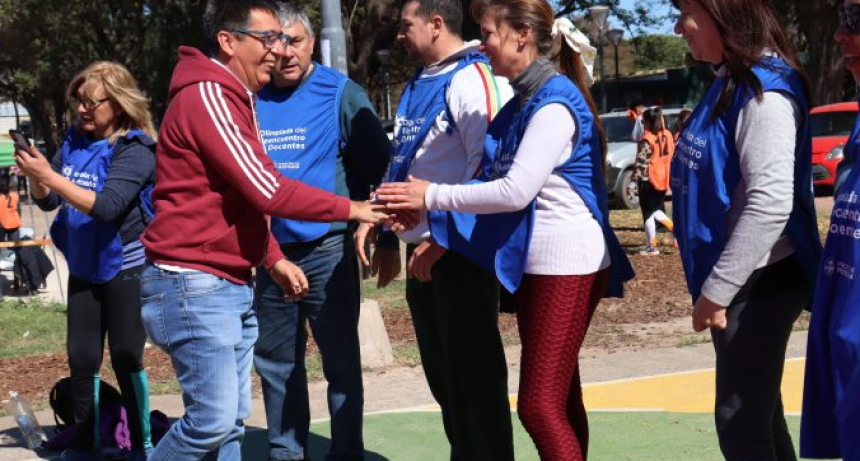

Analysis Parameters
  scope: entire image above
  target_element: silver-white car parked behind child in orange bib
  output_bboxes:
[600,108,682,209]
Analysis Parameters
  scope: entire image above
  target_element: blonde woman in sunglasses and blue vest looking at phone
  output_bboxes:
[14,62,155,461]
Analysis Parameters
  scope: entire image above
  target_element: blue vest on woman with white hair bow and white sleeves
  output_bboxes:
[429,75,634,296]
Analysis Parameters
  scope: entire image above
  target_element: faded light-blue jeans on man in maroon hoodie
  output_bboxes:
[140,264,257,461]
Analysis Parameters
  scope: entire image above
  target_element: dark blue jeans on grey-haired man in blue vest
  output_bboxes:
[254,234,364,461]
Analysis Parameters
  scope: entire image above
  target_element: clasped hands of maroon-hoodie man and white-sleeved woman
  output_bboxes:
[350,176,430,233]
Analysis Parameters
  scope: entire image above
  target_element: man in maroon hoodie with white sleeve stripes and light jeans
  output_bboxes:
[141,0,386,461]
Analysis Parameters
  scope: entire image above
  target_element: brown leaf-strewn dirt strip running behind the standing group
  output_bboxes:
[0,229,693,408]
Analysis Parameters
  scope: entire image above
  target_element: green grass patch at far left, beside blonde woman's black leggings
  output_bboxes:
[0,300,66,359]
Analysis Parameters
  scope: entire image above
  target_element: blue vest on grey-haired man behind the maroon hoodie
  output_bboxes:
[257,63,347,243]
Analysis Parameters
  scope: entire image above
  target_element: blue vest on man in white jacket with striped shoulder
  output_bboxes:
[388,53,489,182]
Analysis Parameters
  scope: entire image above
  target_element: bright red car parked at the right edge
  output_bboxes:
[809,102,857,187]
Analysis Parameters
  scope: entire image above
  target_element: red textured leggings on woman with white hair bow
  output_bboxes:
[514,269,609,461]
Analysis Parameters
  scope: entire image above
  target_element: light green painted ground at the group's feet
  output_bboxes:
[243,412,799,461]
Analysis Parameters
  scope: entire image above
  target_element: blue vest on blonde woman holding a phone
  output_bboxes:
[51,129,148,283]
